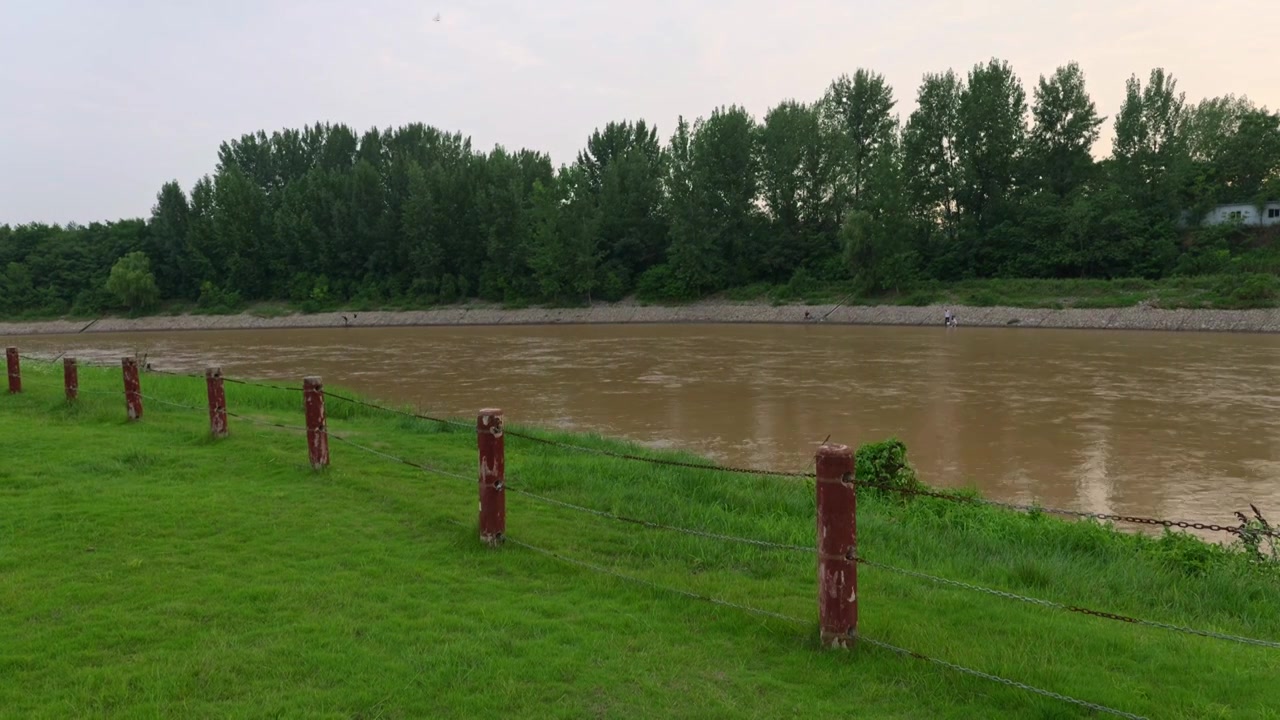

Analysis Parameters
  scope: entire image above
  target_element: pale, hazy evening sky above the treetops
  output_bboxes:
[0,0,1280,224]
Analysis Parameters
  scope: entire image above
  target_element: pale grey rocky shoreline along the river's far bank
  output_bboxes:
[0,302,1280,336]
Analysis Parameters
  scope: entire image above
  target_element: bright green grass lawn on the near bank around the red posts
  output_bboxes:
[0,360,1280,719]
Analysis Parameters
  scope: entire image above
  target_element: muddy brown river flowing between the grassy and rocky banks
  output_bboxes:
[6,324,1280,524]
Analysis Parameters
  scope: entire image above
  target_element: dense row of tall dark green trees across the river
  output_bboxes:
[0,60,1280,313]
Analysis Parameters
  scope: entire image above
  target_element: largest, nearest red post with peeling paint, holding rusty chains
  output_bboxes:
[815,445,858,647]
